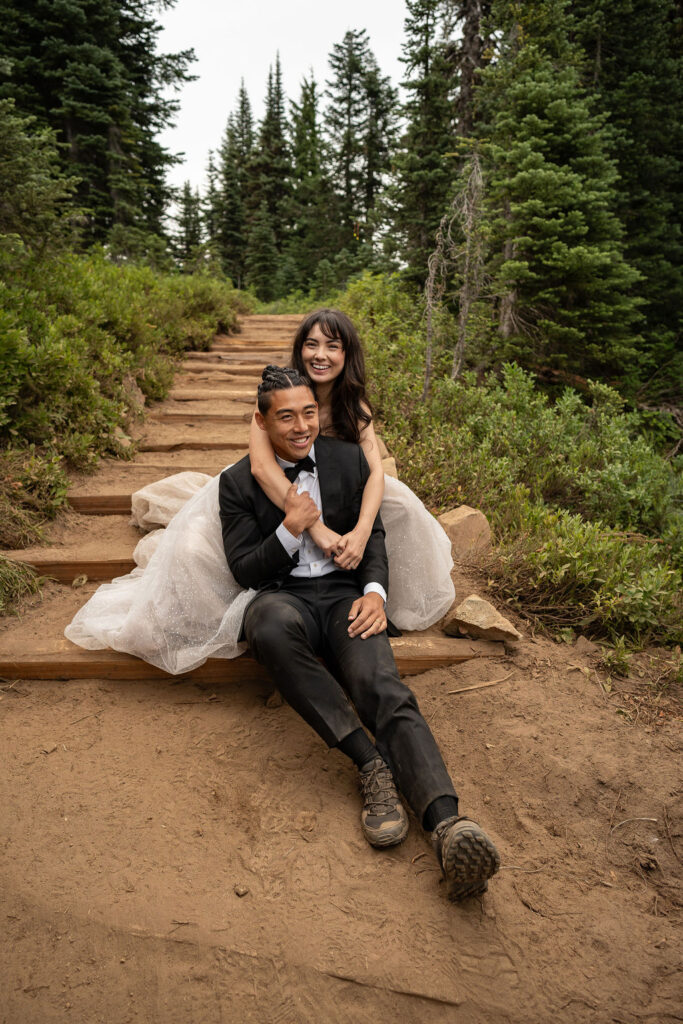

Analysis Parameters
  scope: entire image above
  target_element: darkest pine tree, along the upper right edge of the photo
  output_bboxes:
[569,0,683,395]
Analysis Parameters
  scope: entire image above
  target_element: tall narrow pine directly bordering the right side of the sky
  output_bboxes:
[390,0,457,287]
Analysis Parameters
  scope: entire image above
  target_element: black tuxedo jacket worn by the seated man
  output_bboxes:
[218,437,389,593]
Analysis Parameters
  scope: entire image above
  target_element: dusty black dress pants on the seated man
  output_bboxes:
[244,571,456,821]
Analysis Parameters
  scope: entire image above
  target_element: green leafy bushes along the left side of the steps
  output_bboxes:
[0,239,249,547]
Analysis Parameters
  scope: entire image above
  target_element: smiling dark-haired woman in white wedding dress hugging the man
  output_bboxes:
[65,309,455,674]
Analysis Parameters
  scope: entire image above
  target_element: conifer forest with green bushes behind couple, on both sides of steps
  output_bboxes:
[0,0,683,639]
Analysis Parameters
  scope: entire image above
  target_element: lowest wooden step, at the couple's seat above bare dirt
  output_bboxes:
[0,636,505,683]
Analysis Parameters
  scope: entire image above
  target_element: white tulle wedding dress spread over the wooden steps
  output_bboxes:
[65,473,455,675]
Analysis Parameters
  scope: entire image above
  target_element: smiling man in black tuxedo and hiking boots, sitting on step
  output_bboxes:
[219,367,500,899]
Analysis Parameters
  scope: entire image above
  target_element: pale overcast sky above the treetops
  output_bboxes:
[159,0,405,187]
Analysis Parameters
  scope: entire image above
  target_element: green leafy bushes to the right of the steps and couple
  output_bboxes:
[341,274,683,642]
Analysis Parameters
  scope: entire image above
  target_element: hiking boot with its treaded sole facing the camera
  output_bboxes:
[432,817,501,900]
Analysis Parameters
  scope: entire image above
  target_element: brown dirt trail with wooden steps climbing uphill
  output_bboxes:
[0,316,683,1024]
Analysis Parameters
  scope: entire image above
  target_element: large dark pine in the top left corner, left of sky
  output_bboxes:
[0,0,193,241]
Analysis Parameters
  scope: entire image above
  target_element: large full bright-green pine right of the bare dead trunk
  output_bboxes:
[479,0,638,373]
